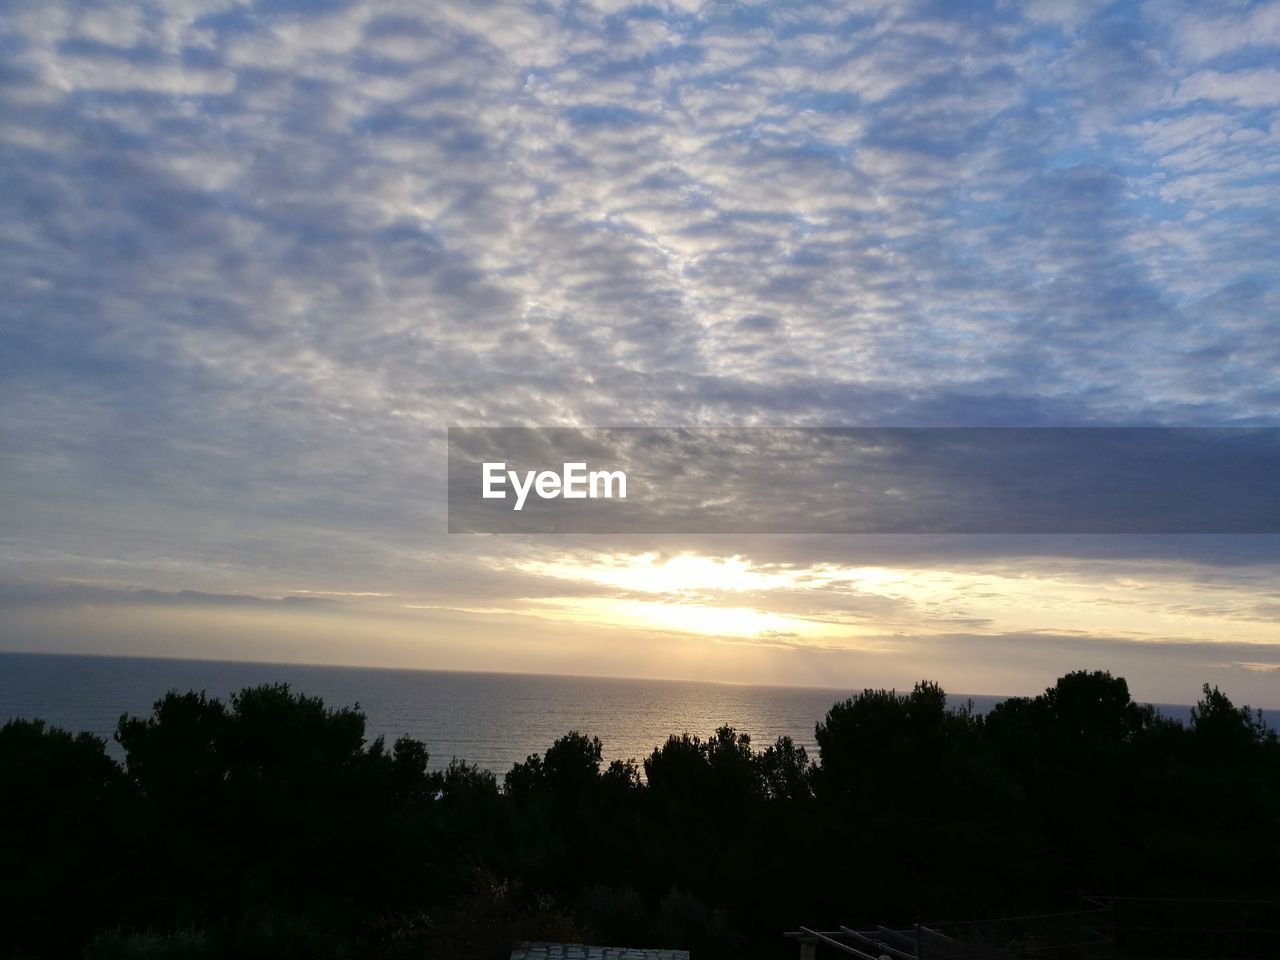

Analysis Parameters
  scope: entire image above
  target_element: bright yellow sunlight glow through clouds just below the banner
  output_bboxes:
[491,552,1274,646]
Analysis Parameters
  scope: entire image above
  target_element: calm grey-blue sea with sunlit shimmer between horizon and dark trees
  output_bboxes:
[0,653,1280,778]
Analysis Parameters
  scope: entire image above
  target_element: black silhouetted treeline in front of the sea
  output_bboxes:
[0,672,1280,960]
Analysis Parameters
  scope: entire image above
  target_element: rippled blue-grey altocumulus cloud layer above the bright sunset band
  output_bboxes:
[0,0,1280,706]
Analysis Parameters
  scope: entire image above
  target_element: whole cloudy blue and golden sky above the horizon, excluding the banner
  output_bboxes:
[0,0,1280,708]
